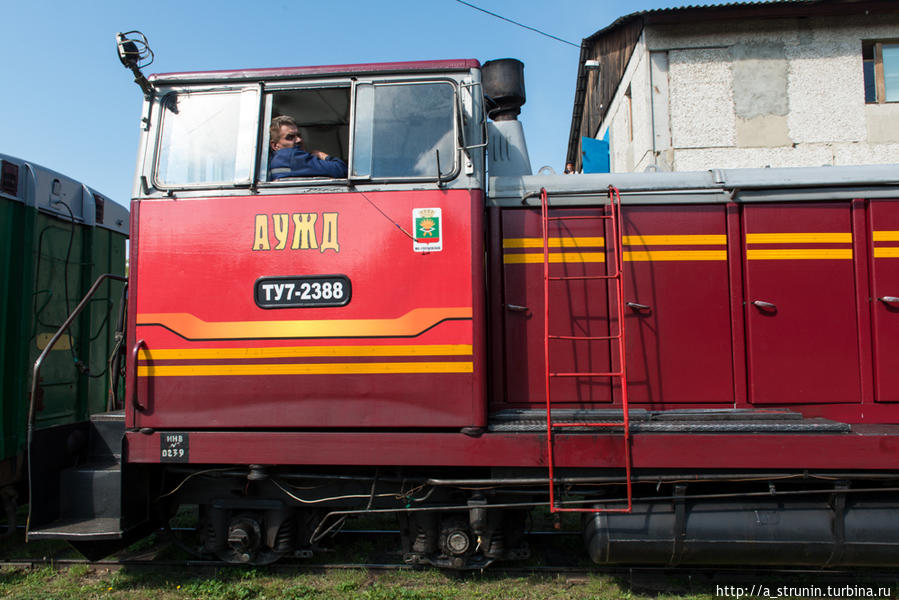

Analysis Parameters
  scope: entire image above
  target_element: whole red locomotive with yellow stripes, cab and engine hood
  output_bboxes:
[21,32,899,568]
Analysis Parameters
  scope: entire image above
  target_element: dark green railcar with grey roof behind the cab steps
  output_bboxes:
[0,154,129,511]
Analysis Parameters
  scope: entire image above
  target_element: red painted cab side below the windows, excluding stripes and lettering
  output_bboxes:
[128,191,486,428]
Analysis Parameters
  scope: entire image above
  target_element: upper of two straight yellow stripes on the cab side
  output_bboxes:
[139,344,472,360]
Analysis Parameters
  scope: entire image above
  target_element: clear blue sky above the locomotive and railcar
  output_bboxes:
[0,0,714,206]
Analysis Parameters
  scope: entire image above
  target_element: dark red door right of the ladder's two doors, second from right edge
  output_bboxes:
[743,202,861,404]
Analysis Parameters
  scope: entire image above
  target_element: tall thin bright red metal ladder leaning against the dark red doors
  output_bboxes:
[540,185,633,513]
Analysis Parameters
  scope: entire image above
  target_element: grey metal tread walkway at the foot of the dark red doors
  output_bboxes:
[488,408,852,433]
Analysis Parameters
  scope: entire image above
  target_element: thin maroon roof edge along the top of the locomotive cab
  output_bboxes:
[149,58,481,84]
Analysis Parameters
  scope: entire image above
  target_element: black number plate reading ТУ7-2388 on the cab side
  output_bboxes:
[253,275,353,308]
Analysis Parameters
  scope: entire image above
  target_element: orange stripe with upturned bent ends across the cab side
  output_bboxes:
[137,306,472,340]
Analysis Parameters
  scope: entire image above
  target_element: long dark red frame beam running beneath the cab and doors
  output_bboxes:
[126,427,899,470]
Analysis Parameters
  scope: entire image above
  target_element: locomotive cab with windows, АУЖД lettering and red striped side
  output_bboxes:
[128,61,485,429]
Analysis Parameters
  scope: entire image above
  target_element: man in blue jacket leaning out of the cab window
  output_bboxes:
[269,116,347,181]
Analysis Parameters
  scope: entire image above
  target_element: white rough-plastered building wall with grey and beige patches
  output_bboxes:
[599,15,899,172]
